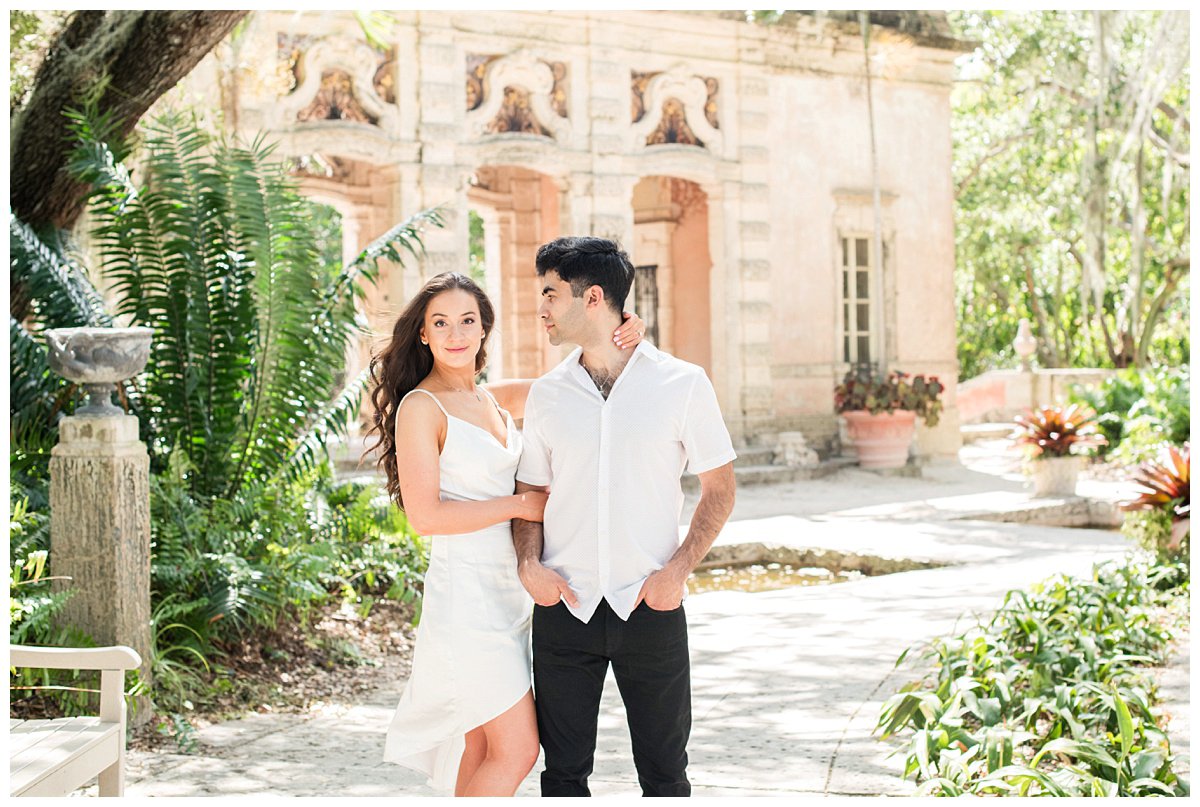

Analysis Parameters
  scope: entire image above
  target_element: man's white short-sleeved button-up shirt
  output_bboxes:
[517,342,737,622]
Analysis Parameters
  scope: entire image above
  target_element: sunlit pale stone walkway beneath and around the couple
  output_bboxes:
[87,449,1188,796]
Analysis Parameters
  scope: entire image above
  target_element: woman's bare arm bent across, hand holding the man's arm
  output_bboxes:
[396,395,546,536]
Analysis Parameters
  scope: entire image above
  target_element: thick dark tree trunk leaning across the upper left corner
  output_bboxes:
[8,11,247,228]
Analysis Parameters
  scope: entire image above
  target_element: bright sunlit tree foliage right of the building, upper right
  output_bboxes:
[948,11,1190,378]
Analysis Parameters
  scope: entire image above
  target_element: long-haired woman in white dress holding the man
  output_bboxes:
[371,273,642,796]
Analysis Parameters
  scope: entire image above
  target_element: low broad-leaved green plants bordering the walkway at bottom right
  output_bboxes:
[876,554,1189,796]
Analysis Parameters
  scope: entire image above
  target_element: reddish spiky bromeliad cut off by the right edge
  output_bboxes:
[1121,443,1192,563]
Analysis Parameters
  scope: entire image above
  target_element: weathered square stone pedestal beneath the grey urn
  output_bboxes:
[50,414,152,724]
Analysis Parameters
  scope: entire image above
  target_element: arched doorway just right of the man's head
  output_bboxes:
[630,177,713,376]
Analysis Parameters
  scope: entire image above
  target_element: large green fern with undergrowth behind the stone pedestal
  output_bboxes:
[10,108,443,704]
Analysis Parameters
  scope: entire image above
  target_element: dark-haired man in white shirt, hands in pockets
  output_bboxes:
[512,232,736,796]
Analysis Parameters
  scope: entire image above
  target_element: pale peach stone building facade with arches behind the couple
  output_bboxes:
[181,11,961,454]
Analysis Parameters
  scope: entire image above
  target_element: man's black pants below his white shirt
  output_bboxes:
[533,599,691,796]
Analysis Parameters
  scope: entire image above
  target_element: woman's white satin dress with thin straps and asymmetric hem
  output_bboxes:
[384,389,533,790]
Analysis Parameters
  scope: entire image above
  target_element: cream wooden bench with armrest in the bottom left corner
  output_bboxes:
[8,646,142,796]
